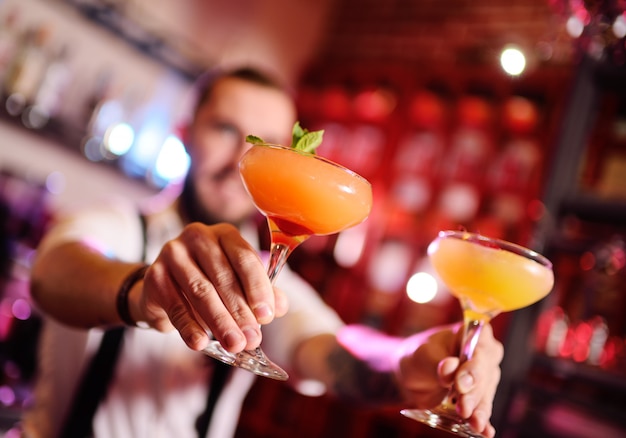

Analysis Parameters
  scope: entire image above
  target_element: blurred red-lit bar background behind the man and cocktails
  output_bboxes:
[0,0,626,438]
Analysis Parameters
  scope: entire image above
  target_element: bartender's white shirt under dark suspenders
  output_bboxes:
[23,196,342,438]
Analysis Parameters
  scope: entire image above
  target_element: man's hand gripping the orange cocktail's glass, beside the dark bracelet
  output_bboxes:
[134,223,287,352]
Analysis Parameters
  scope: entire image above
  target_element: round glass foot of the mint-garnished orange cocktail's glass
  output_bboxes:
[202,341,289,380]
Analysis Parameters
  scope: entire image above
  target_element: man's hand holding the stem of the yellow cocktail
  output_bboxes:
[397,324,504,437]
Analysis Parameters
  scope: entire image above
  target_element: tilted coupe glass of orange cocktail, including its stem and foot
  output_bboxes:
[204,144,372,380]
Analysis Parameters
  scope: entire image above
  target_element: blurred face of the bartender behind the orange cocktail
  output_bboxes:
[187,78,296,224]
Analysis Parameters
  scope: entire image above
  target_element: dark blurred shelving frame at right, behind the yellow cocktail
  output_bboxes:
[493,56,626,438]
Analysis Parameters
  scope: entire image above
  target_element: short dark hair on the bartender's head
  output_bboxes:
[192,67,293,115]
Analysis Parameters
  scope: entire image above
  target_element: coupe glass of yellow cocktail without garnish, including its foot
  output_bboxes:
[401,231,554,437]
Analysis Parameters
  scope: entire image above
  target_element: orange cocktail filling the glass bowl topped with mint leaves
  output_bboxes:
[239,145,372,240]
